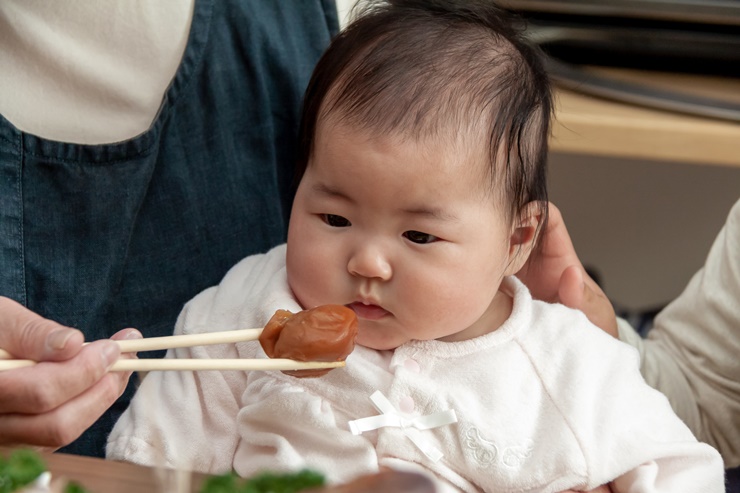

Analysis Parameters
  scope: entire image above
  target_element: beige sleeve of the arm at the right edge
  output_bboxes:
[619,200,740,467]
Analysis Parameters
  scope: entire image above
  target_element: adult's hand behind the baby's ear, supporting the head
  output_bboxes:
[517,203,618,337]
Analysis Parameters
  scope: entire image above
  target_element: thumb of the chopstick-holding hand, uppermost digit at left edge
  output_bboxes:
[0,296,84,361]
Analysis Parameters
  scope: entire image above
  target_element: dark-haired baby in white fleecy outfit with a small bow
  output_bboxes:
[107,0,724,493]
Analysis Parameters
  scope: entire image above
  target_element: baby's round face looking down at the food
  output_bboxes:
[287,123,521,350]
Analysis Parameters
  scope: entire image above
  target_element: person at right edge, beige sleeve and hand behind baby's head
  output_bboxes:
[518,200,740,472]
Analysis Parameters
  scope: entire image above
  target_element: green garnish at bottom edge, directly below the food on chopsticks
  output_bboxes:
[200,469,326,493]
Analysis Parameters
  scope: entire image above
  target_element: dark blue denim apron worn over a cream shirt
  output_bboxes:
[0,0,337,456]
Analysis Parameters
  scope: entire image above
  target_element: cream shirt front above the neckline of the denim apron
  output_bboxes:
[0,0,194,144]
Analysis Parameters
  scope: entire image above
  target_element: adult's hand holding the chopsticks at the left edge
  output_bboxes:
[0,296,141,450]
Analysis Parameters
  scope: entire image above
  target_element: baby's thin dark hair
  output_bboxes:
[297,0,552,236]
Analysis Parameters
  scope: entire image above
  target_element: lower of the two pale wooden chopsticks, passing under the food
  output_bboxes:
[0,358,345,371]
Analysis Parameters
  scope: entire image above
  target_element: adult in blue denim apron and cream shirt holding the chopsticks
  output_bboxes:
[0,0,338,456]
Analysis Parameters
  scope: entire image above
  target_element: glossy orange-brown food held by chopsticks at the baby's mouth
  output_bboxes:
[259,305,357,377]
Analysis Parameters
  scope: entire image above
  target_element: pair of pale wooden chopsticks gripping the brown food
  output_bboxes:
[0,329,345,371]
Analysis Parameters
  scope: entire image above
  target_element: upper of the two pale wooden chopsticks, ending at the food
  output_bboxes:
[0,329,262,360]
